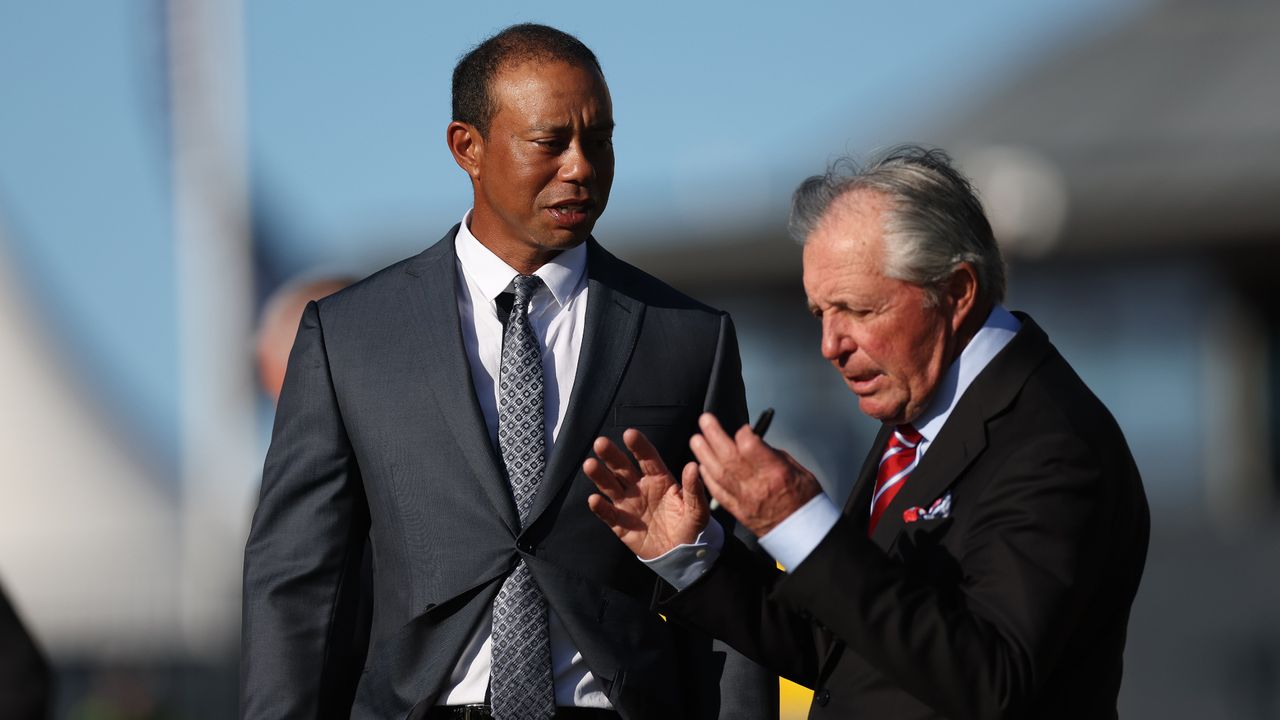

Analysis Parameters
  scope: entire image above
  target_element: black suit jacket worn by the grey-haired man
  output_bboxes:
[659,315,1149,720]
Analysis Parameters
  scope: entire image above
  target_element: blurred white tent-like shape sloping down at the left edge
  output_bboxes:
[0,225,179,657]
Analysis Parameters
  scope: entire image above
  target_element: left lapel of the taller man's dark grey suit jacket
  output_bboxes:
[406,227,520,533]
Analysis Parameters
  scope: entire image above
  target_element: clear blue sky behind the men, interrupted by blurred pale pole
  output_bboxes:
[0,0,1142,466]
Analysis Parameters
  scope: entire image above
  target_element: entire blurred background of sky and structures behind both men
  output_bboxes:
[0,0,1280,720]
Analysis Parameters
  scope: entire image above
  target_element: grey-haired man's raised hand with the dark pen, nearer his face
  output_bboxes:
[686,413,822,537]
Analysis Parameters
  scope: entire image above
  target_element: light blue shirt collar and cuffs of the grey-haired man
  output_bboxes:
[645,305,1021,591]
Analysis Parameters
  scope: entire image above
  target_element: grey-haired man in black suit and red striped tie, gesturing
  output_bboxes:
[585,142,1149,720]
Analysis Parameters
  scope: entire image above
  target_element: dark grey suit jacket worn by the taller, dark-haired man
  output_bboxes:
[241,228,776,719]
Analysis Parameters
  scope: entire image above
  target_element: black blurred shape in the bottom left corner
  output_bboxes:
[0,576,52,720]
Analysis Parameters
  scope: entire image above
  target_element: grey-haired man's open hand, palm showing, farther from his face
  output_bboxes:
[582,428,710,560]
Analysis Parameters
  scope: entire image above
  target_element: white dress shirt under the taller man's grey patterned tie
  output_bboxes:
[438,211,612,707]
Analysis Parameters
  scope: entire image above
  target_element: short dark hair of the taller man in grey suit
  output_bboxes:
[453,23,604,135]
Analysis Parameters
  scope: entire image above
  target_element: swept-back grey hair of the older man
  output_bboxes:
[788,145,1005,304]
